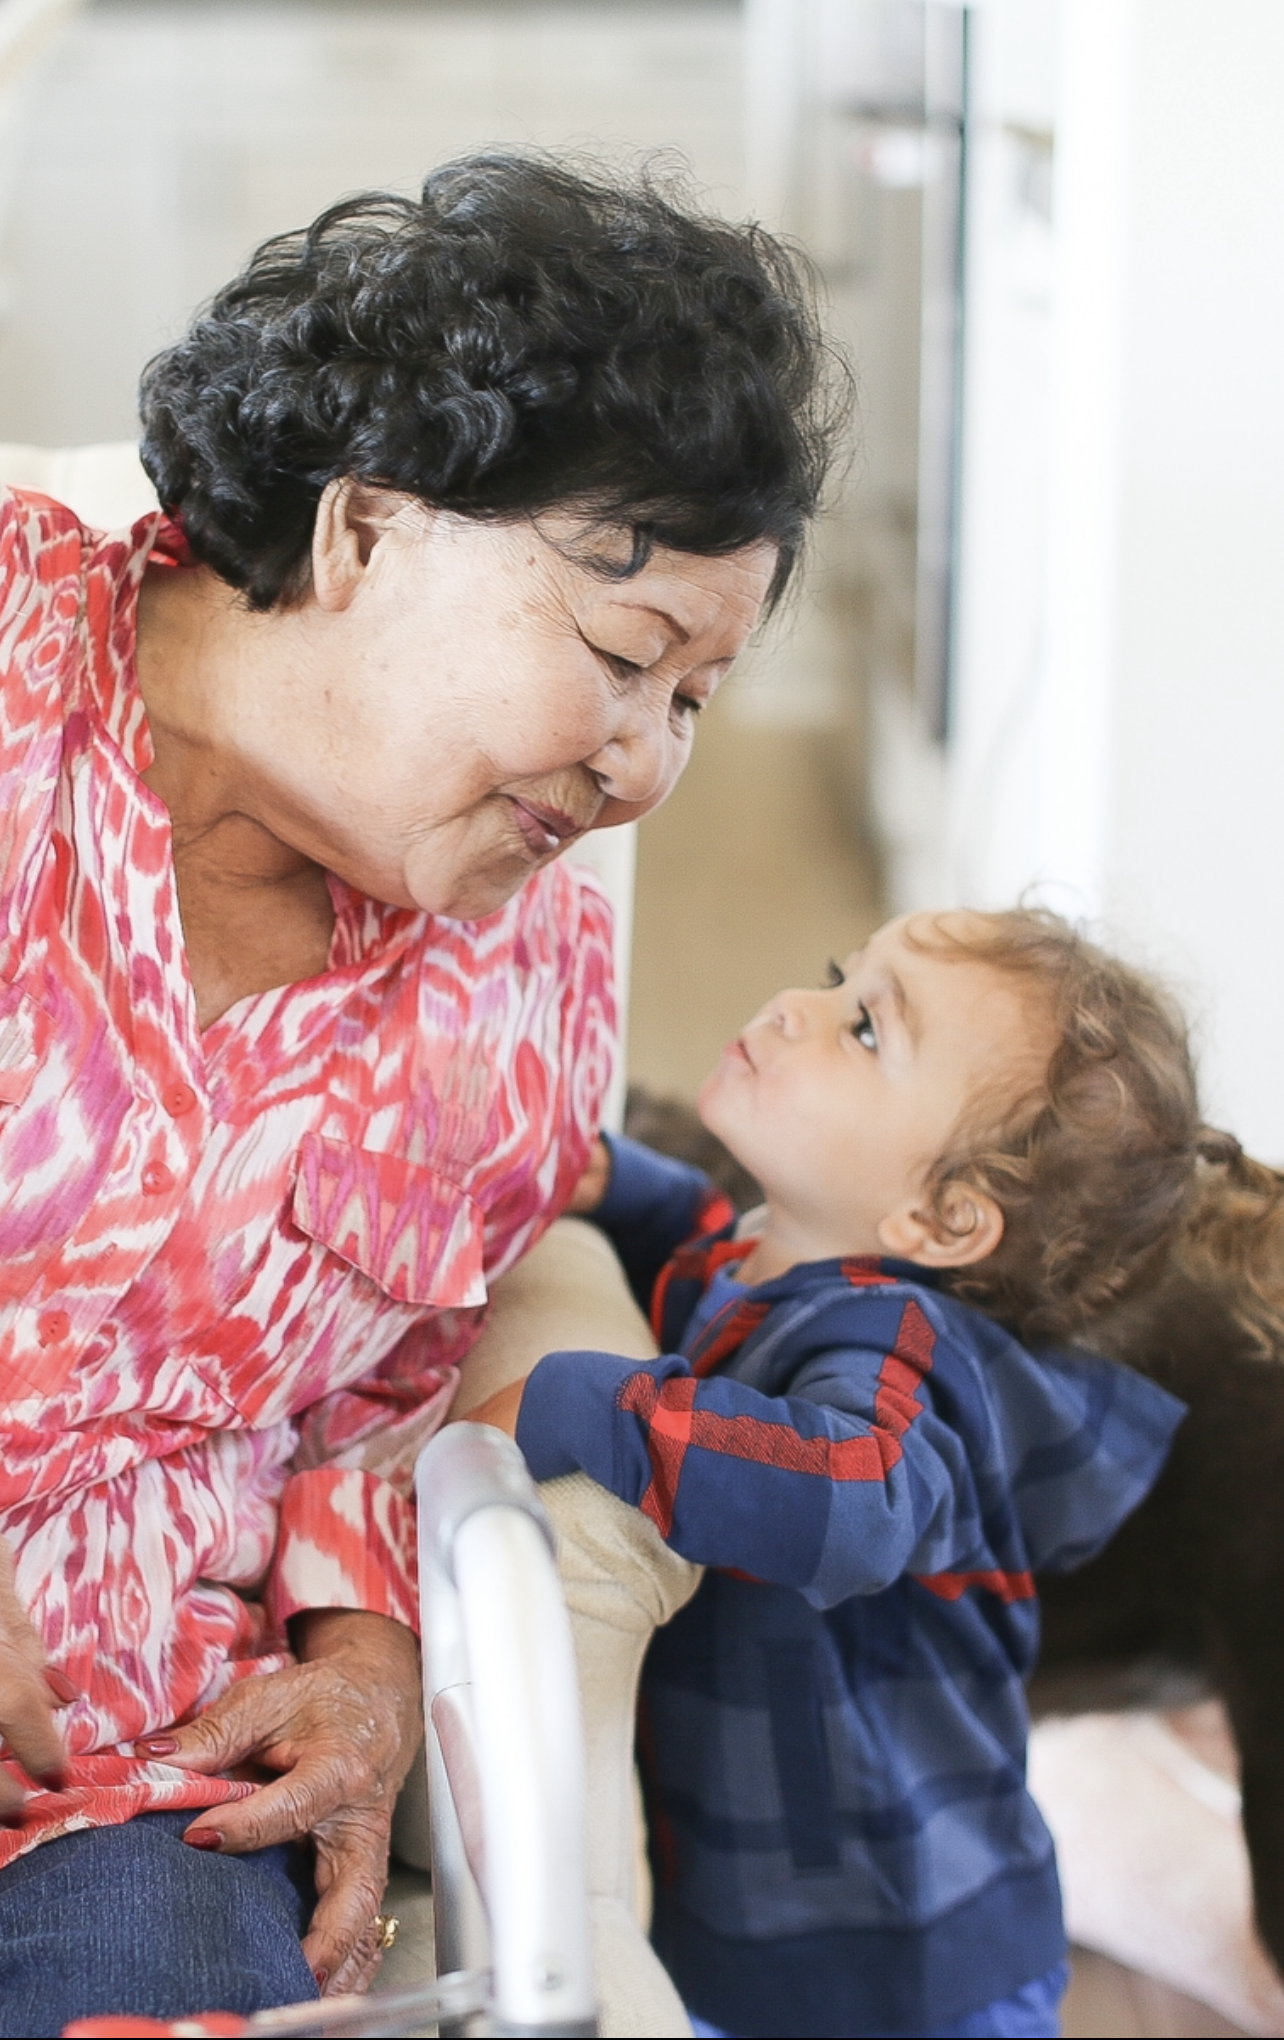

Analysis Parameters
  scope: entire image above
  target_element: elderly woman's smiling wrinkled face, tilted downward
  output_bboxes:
[278,492,776,918]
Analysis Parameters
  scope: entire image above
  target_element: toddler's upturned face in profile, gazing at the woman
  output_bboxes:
[698,916,1051,1265]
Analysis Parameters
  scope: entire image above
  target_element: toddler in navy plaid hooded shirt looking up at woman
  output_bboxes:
[476,912,1227,2036]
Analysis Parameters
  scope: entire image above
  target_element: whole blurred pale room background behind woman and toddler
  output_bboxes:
[0,0,1284,1161]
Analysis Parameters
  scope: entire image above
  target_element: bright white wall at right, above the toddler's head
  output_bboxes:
[951,0,1284,1159]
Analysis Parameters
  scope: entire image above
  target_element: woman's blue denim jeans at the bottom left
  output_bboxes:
[0,1807,316,2040]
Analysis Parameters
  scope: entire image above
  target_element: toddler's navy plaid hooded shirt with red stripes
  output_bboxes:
[516,1140,1184,2036]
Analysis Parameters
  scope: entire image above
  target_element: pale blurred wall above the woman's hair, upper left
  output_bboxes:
[0,0,743,445]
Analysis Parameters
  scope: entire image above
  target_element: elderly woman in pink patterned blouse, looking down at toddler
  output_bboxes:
[0,157,833,2034]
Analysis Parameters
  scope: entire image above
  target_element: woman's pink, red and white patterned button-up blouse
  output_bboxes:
[0,490,614,1863]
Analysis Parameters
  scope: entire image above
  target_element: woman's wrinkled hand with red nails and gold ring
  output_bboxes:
[137,1610,423,1993]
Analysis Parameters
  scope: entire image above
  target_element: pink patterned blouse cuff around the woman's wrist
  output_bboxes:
[265,1467,418,1634]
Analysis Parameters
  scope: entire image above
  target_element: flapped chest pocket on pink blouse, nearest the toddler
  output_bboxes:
[292,1134,486,1310]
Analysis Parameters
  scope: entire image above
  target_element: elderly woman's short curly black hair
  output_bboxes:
[141,155,849,610]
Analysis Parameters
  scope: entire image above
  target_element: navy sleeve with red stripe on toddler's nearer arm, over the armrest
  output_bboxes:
[516,1299,975,1608]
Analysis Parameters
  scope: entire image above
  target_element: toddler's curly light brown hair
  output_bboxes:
[906,908,1284,1353]
